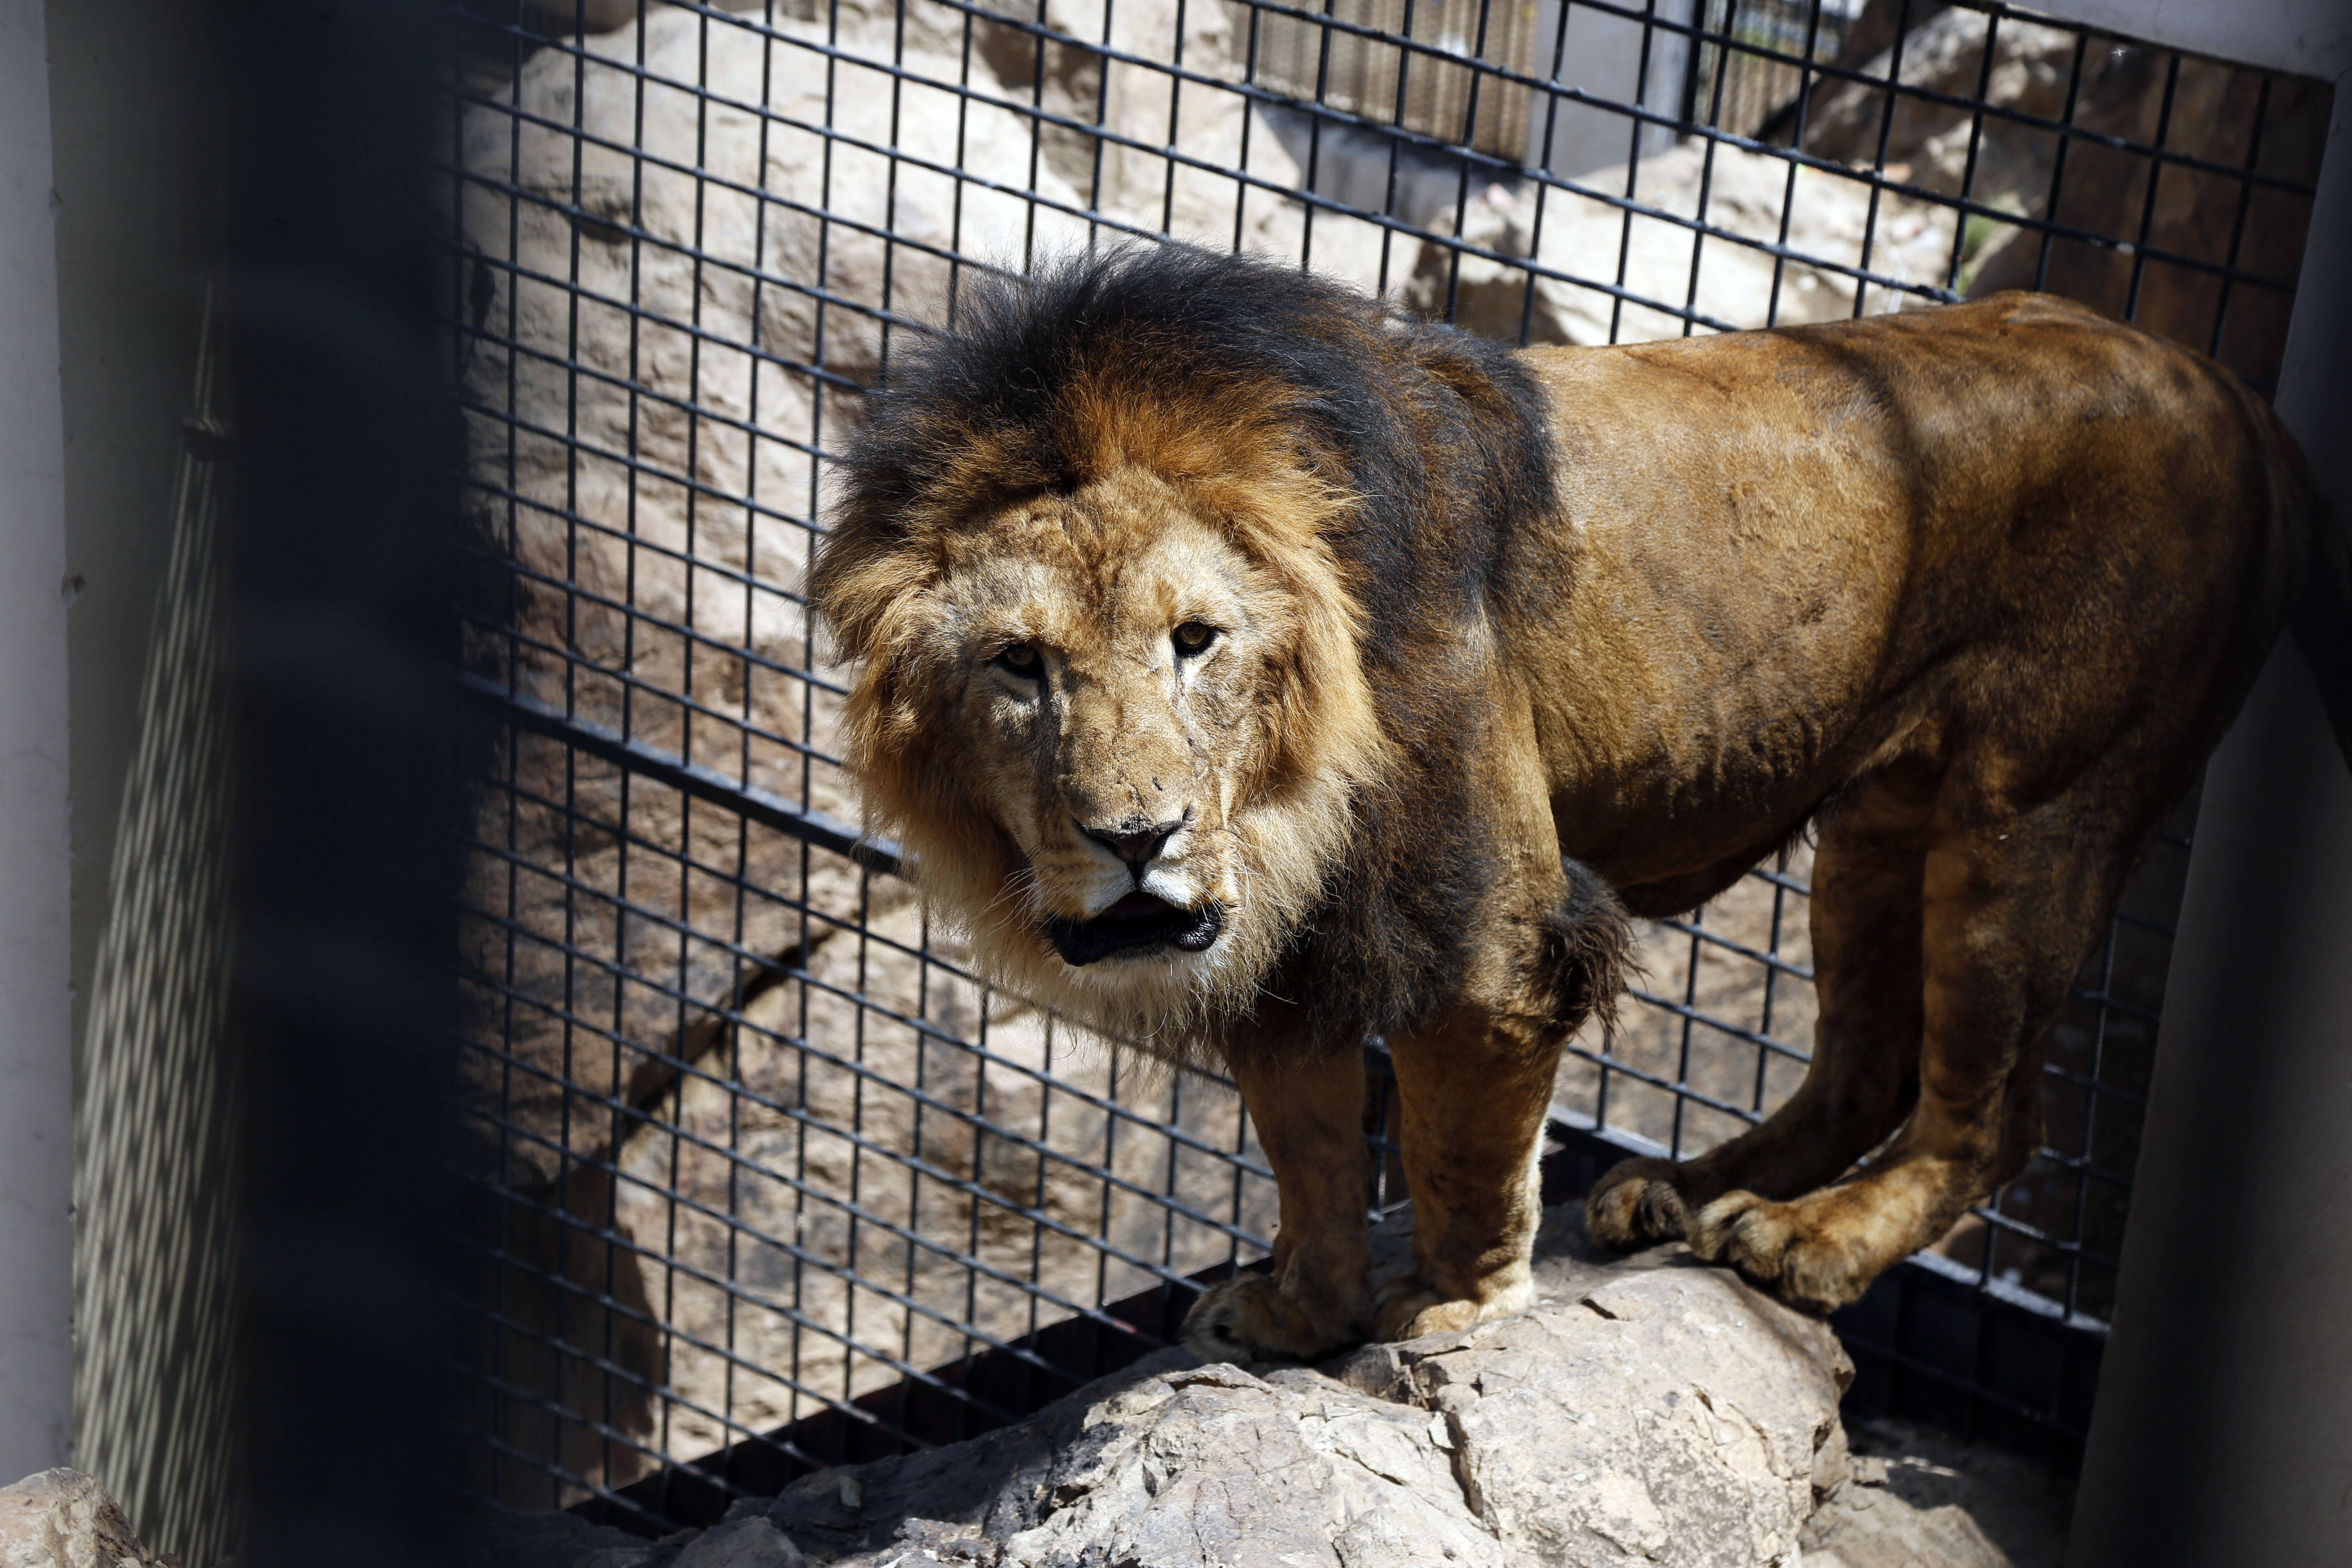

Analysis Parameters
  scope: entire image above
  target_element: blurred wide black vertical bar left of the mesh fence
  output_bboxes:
[227,0,461,1568]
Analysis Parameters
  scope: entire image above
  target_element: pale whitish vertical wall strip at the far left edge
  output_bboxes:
[0,0,73,1481]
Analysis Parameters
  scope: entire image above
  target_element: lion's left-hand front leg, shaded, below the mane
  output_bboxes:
[1183,1051,1371,1363]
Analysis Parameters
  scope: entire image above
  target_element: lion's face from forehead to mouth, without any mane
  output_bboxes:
[941,472,1282,949]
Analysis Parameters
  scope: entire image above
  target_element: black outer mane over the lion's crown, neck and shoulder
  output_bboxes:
[840,245,1557,1049]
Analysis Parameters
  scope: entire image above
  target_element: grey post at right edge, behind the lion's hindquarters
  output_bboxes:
[2067,55,2352,1568]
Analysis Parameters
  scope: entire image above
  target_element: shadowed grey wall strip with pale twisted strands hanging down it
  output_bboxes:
[47,0,233,1563]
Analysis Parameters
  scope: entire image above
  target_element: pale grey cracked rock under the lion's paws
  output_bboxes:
[468,1206,2063,1568]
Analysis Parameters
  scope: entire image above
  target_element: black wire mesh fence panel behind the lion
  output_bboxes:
[440,0,2328,1526]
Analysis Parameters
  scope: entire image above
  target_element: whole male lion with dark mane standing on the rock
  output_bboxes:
[811,247,2352,1359]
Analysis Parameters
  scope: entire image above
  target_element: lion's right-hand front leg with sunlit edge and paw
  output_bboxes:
[1374,1011,1562,1340]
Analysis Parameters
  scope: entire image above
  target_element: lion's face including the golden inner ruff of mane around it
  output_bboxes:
[823,454,1376,1037]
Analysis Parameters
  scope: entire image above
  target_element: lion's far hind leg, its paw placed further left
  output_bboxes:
[1585,769,1936,1246]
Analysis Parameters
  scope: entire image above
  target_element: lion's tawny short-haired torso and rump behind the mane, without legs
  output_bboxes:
[1519,294,2296,879]
